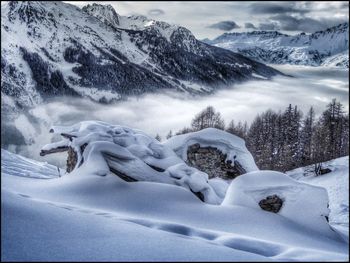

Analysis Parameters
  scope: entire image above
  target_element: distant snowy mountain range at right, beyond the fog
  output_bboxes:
[205,23,349,68]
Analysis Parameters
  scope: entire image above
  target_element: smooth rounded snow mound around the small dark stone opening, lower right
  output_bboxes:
[222,171,332,238]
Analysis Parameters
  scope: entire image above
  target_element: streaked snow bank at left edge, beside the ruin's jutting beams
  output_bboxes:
[1,149,60,179]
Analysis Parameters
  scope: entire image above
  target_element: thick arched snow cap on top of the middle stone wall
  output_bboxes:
[163,128,259,172]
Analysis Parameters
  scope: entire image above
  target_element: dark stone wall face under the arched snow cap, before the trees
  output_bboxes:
[187,144,246,179]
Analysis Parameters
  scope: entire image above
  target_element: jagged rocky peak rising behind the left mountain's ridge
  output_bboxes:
[82,3,119,27]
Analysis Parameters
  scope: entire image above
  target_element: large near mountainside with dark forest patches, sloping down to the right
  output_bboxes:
[1,1,279,114]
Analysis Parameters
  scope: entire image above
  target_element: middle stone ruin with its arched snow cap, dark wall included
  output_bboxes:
[163,128,258,179]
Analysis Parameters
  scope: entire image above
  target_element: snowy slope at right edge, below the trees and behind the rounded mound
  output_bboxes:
[287,156,349,243]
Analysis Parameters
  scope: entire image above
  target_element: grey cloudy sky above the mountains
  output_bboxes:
[67,1,349,39]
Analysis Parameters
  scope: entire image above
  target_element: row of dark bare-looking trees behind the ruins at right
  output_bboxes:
[167,99,349,174]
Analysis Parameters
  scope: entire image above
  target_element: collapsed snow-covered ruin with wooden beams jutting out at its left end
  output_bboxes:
[40,121,222,204]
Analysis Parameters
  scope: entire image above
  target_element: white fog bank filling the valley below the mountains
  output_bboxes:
[5,66,349,167]
